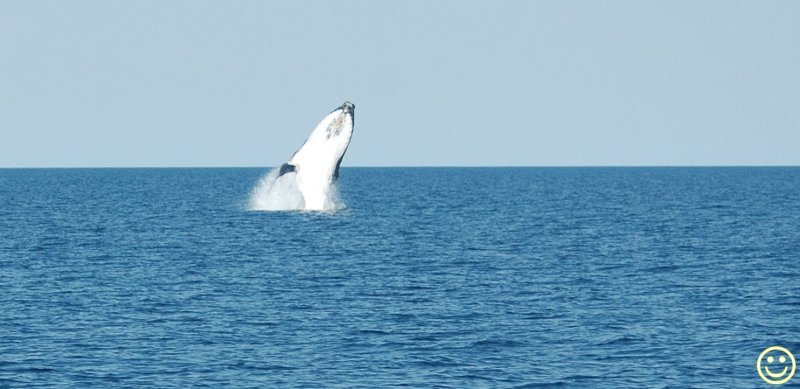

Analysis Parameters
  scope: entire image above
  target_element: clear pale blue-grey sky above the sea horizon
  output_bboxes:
[0,0,800,167]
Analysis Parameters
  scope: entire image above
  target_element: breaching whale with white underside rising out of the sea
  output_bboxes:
[277,101,356,211]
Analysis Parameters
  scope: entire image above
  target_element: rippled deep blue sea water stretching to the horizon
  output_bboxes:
[0,168,800,388]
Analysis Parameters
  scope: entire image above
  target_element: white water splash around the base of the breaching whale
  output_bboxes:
[248,168,345,212]
